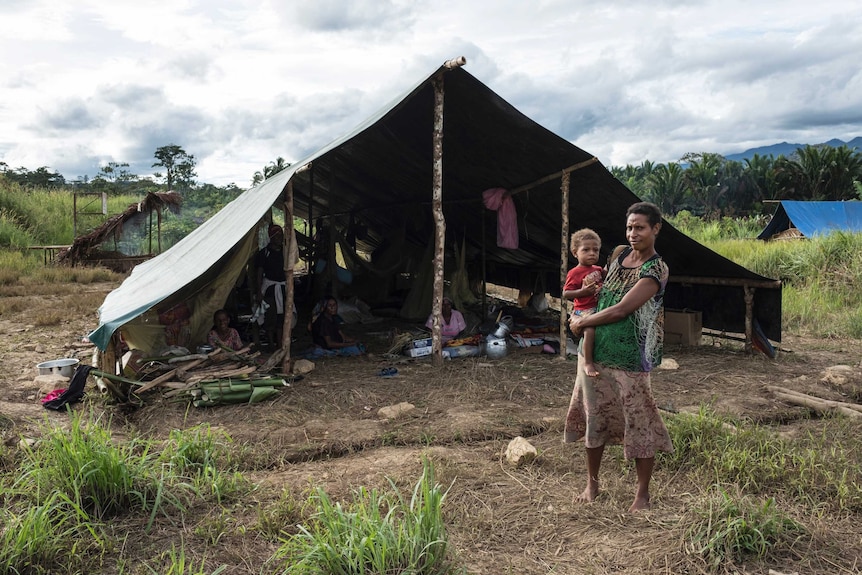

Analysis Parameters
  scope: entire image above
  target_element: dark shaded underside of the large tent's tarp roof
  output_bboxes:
[294,64,781,341]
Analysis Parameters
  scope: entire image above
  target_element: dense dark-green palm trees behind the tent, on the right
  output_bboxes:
[610,145,862,219]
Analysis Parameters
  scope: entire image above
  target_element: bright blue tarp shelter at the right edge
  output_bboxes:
[757,201,862,240]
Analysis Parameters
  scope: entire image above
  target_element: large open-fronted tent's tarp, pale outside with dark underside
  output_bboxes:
[90,60,781,349]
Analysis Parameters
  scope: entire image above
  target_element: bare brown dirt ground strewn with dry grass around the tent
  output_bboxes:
[0,284,862,575]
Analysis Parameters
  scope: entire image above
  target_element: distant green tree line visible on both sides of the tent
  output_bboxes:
[0,144,862,219]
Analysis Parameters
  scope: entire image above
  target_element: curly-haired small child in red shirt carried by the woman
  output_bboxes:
[563,228,607,377]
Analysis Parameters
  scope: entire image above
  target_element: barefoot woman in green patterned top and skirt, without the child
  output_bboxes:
[563,202,673,511]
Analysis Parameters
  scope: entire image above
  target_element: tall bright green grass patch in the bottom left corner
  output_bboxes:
[0,411,262,574]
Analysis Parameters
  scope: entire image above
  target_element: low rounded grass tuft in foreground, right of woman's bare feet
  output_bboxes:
[686,490,805,569]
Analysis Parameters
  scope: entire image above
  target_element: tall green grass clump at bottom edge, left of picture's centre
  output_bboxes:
[276,460,466,575]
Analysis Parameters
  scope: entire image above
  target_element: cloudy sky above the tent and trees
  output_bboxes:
[0,0,862,187]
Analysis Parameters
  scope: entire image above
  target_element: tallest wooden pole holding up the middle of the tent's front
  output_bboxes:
[431,75,446,367]
